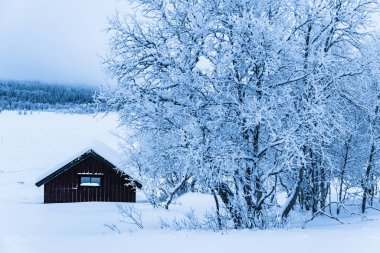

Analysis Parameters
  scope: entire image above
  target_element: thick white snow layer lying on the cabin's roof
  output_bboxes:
[36,139,122,185]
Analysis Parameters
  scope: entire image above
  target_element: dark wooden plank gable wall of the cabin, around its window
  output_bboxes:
[44,155,136,203]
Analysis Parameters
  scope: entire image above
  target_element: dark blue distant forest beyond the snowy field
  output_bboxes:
[0,81,97,113]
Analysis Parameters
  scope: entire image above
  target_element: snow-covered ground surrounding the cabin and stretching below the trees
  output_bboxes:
[0,112,380,253]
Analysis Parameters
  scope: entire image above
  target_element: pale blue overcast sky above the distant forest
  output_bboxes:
[0,0,128,84]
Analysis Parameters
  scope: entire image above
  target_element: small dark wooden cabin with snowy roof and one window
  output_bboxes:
[36,144,141,203]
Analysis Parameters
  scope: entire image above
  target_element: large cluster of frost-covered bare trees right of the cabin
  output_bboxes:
[99,0,380,228]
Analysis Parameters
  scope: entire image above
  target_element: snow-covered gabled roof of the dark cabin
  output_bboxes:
[36,140,132,186]
